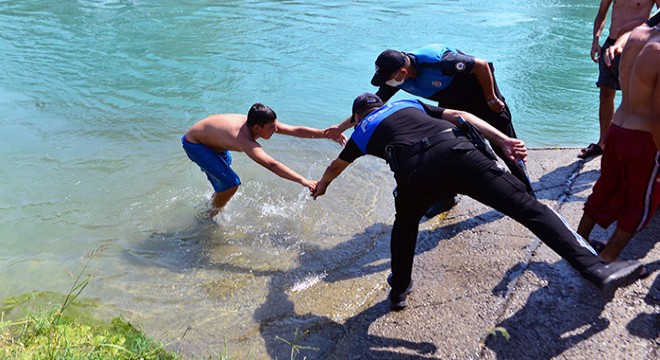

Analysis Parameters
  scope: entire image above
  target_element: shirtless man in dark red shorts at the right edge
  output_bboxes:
[578,13,660,262]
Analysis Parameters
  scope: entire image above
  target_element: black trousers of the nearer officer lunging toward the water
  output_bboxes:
[391,137,603,291]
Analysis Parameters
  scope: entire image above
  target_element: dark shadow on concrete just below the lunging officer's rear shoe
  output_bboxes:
[485,261,609,359]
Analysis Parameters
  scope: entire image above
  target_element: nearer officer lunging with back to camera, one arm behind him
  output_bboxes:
[312,93,642,310]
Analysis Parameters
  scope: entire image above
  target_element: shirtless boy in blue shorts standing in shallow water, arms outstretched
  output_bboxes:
[181,103,346,217]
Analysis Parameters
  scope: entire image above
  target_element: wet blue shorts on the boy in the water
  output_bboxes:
[181,135,241,192]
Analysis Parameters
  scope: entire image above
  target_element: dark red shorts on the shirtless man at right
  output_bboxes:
[584,124,660,233]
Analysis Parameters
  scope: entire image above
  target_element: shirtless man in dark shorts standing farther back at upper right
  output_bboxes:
[578,0,660,159]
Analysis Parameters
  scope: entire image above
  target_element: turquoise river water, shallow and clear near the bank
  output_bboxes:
[0,0,612,354]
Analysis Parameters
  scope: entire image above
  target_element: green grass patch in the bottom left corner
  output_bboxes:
[0,248,179,359]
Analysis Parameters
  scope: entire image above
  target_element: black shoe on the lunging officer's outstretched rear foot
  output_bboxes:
[592,260,644,298]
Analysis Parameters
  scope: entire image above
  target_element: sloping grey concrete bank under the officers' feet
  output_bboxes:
[260,148,660,359]
